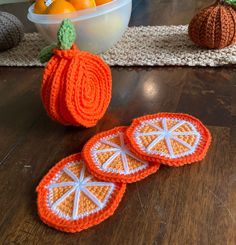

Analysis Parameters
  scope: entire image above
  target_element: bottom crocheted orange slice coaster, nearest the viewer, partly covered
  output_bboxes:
[37,153,126,232]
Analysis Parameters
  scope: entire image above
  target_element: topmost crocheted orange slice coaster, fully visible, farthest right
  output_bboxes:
[126,113,211,166]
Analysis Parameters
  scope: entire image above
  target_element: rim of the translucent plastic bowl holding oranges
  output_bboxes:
[27,0,132,24]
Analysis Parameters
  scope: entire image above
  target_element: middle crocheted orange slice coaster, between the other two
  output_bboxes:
[82,127,160,183]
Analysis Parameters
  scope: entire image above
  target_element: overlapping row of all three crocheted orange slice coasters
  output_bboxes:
[37,113,211,232]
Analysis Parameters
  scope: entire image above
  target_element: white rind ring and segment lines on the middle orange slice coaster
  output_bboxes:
[91,132,149,175]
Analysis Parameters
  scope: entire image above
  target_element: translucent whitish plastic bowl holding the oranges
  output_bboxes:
[28,0,132,53]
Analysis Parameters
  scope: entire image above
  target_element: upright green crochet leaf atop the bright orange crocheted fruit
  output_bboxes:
[57,19,76,49]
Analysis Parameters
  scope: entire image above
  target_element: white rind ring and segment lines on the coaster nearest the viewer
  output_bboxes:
[46,161,115,220]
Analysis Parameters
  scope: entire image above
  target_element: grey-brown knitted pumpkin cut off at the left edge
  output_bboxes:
[0,11,24,51]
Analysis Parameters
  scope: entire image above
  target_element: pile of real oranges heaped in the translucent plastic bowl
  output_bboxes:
[34,0,112,14]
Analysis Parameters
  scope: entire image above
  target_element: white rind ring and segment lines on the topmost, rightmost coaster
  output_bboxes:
[134,118,201,159]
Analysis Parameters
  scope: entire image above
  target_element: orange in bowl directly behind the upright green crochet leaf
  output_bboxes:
[46,0,76,14]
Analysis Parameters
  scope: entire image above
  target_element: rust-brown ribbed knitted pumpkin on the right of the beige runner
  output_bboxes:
[188,0,236,49]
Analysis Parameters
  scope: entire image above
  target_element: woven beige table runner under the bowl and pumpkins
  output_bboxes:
[0,26,236,67]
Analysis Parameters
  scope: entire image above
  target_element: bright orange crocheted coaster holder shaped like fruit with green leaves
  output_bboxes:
[40,19,112,127]
